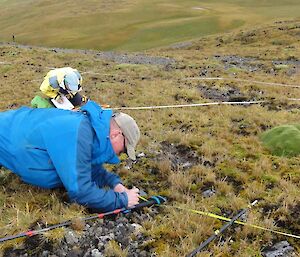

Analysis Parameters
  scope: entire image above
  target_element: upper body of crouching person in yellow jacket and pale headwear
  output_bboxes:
[40,67,88,107]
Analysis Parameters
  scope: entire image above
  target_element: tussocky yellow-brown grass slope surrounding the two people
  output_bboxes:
[0,19,300,257]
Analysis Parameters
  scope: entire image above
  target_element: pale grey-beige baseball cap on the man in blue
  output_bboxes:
[113,112,141,161]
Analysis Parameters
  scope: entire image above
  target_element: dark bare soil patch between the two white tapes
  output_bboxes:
[198,85,250,102]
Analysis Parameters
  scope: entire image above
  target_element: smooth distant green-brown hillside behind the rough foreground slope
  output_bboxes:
[0,0,300,51]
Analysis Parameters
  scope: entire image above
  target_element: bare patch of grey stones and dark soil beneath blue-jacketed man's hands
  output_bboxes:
[3,208,157,257]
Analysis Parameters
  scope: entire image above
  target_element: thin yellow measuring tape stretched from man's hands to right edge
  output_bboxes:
[139,196,300,239]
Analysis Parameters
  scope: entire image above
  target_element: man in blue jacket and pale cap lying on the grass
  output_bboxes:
[0,101,140,211]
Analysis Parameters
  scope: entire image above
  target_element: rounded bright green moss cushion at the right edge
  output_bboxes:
[261,124,300,157]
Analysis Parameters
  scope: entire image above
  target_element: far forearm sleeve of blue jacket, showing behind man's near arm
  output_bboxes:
[92,165,122,189]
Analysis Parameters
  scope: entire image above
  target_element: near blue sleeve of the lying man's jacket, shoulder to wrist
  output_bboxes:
[45,118,128,211]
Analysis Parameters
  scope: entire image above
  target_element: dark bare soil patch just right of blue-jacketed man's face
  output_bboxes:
[156,141,215,170]
